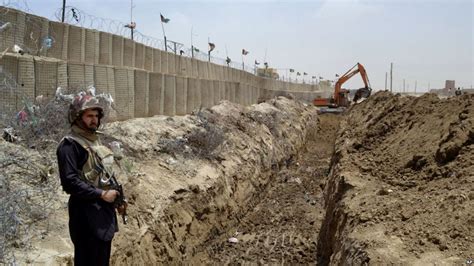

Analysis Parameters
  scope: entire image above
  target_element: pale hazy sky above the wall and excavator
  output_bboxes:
[4,0,474,92]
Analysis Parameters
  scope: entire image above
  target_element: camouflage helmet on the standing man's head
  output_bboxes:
[68,92,104,124]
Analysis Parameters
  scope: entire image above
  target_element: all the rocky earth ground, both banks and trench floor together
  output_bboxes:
[0,92,474,265]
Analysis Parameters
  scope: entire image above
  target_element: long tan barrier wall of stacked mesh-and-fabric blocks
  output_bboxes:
[0,7,331,120]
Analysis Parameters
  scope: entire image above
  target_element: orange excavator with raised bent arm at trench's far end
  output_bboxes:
[313,63,372,108]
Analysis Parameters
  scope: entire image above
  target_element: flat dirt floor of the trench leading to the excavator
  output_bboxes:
[193,114,341,265]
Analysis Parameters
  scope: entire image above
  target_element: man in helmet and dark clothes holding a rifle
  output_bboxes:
[56,93,126,266]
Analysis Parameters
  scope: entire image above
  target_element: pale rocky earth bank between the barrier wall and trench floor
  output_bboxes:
[0,97,318,265]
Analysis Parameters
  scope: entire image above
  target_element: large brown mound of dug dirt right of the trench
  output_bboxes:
[318,92,474,265]
